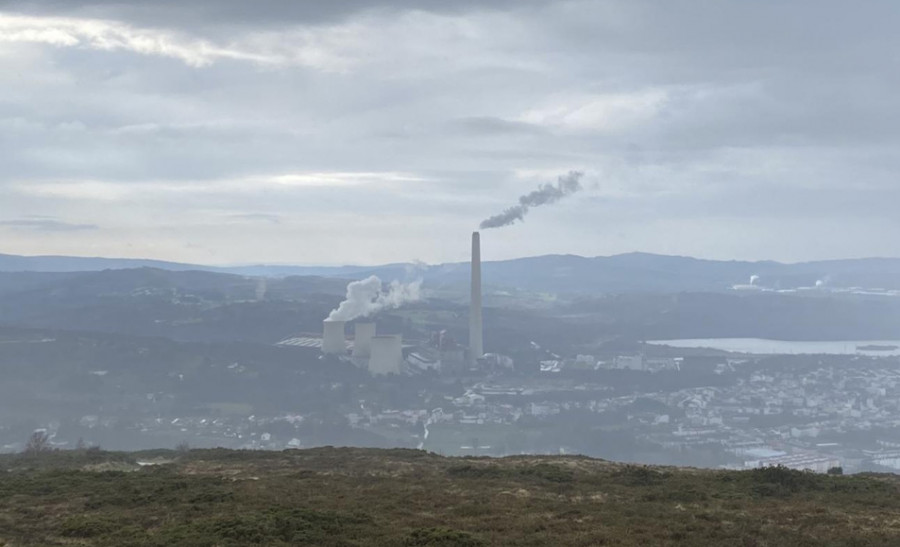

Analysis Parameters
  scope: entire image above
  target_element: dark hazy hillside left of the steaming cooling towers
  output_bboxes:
[0,268,347,343]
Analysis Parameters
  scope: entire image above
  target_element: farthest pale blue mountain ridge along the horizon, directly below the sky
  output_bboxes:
[0,253,900,293]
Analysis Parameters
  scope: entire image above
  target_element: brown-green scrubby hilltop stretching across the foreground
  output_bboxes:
[0,448,900,546]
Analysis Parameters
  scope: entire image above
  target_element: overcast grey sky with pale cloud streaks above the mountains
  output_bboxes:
[0,0,900,264]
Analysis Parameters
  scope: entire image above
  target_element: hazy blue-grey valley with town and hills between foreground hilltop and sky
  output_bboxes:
[0,248,900,471]
